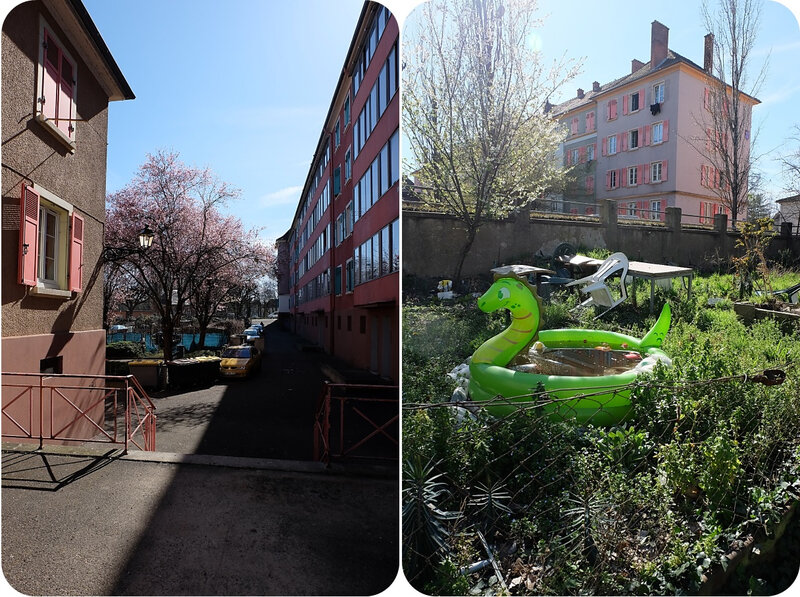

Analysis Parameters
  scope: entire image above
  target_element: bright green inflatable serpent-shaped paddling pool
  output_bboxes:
[469,275,671,425]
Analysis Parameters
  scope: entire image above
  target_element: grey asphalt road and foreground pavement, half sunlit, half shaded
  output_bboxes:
[2,322,399,595]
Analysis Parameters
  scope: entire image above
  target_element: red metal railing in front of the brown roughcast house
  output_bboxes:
[2,373,156,453]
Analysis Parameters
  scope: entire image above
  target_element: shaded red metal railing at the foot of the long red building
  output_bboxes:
[314,382,400,463]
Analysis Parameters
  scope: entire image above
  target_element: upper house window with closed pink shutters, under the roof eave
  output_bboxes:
[36,21,78,151]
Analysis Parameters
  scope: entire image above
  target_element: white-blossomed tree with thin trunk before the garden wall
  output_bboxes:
[403,0,576,283]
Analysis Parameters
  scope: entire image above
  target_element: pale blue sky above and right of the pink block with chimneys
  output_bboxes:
[404,0,800,200]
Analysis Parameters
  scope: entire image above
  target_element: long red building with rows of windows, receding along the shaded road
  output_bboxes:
[278,2,400,382]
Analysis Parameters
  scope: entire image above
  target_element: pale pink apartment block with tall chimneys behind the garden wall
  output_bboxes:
[552,21,759,225]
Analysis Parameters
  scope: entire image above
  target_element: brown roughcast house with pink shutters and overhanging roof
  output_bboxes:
[2,0,134,434]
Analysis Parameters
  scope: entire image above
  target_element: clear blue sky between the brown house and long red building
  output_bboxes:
[84,0,362,240]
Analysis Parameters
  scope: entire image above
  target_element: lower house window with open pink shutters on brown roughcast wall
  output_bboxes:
[19,185,84,298]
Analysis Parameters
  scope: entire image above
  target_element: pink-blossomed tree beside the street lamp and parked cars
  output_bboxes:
[105,152,274,359]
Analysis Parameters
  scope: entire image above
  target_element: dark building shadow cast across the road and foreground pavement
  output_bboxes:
[113,322,399,595]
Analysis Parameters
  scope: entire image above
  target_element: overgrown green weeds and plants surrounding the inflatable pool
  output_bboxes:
[403,268,800,595]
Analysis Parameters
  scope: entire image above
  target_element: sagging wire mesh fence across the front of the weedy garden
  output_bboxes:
[403,363,800,595]
